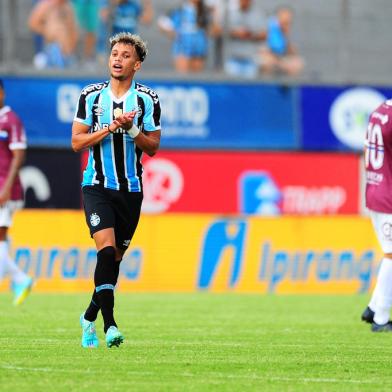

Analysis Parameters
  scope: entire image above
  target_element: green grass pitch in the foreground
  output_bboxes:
[0,293,392,392]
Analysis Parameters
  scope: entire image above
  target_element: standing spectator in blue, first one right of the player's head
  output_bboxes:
[158,0,209,73]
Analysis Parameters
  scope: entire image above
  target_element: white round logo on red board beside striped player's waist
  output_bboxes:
[142,158,184,214]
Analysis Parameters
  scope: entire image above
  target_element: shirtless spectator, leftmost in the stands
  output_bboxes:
[28,0,78,68]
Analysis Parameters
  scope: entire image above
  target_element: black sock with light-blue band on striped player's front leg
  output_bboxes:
[94,246,117,333]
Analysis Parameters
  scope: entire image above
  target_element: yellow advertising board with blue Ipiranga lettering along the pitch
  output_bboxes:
[0,210,381,293]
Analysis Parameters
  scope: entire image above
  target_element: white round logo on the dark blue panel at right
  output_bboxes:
[329,88,385,150]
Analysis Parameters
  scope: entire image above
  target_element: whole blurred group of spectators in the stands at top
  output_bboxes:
[29,0,304,77]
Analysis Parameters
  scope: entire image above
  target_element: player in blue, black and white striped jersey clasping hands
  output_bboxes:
[72,33,161,347]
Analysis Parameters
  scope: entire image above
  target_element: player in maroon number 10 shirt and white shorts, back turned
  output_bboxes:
[362,100,392,332]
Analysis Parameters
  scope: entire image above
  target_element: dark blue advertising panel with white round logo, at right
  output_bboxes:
[301,86,392,151]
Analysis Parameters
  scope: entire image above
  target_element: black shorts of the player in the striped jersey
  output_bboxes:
[82,186,143,250]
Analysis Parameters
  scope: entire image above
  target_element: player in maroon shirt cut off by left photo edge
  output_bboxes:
[0,80,33,305]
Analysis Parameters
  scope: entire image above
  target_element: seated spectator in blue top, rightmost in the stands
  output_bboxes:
[260,6,304,75]
